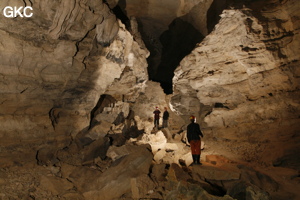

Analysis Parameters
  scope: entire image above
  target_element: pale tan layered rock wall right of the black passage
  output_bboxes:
[171,1,300,167]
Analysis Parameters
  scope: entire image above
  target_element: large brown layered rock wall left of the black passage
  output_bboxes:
[0,0,149,144]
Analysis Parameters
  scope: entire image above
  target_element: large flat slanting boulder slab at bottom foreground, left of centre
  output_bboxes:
[83,146,153,200]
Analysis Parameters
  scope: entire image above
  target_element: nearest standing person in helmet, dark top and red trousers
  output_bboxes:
[187,116,203,165]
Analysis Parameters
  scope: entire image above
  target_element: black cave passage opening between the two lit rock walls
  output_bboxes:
[138,18,204,94]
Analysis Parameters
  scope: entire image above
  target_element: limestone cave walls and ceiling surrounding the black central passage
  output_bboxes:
[0,0,299,171]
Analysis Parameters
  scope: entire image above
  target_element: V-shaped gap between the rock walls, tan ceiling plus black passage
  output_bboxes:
[112,0,223,94]
